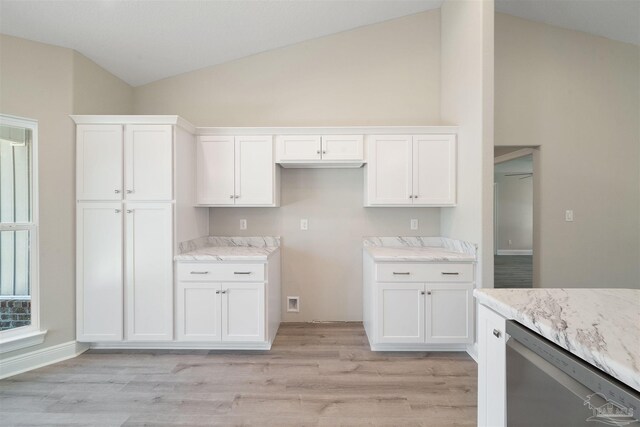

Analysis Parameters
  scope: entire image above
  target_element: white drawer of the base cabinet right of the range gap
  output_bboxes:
[376,263,473,282]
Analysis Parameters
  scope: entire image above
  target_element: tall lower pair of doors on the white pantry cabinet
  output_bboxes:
[76,202,173,342]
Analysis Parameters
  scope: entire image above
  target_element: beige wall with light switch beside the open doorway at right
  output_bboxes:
[495,14,640,288]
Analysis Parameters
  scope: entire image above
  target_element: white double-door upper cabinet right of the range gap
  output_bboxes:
[365,135,457,206]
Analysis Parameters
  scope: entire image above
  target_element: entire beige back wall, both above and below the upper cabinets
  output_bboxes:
[135,10,440,321]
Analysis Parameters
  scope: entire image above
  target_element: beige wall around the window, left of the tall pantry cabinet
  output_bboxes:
[0,35,131,358]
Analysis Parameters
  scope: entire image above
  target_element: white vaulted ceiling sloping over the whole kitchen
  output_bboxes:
[0,0,640,86]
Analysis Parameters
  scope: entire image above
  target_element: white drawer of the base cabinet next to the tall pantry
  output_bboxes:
[177,263,265,282]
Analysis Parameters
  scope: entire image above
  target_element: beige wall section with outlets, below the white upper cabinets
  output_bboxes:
[210,169,440,322]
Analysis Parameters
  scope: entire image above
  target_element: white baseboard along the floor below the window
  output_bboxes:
[0,341,89,379]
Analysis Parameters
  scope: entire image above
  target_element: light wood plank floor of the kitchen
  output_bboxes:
[0,323,477,427]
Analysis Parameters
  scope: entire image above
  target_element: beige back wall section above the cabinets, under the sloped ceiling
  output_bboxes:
[135,10,440,126]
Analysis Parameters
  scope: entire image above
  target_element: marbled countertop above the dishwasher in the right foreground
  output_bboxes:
[474,289,640,391]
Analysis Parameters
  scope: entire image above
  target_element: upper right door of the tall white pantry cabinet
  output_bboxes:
[124,125,173,201]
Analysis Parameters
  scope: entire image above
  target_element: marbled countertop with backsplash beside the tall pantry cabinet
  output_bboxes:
[174,236,280,261]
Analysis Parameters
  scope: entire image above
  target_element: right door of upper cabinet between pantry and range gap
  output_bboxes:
[235,136,276,206]
